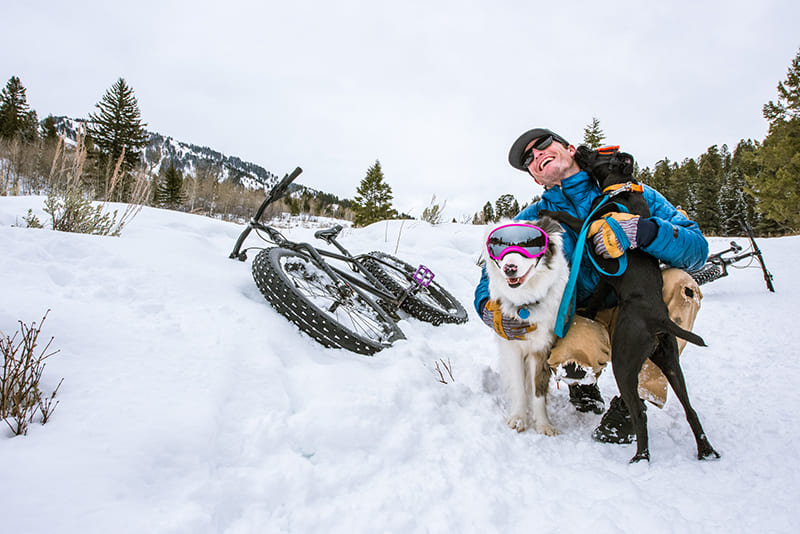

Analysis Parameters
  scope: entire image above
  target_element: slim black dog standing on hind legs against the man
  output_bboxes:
[539,146,719,462]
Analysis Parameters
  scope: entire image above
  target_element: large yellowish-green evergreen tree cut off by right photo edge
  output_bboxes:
[747,48,800,232]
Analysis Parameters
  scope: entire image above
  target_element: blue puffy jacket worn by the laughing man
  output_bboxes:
[475,171,708,315]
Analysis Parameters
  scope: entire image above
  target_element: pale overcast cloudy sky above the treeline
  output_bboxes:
[0,0,800,219]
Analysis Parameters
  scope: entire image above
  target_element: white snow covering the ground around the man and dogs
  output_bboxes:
[0,197,800,534]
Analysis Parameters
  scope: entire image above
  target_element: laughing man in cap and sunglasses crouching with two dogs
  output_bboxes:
[475,128,708,443]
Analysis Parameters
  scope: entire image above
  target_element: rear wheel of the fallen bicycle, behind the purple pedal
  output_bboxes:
[361,252,468,325]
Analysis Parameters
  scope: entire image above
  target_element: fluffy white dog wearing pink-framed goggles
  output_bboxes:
[483,218,569,436]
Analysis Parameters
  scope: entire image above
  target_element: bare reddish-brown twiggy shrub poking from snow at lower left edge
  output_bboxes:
[0,310,64,435]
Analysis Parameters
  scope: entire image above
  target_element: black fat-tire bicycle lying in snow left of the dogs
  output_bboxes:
[229,167,468,355]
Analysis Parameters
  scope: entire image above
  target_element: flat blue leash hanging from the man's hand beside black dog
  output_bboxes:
[555,195,631,337]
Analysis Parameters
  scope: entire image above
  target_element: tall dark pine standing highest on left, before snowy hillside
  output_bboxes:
[88,78,149,201]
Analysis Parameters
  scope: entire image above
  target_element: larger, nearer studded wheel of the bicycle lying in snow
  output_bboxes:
[253,247,405,354]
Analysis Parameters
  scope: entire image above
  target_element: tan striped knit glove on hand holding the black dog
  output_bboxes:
[588,216,658,259]
